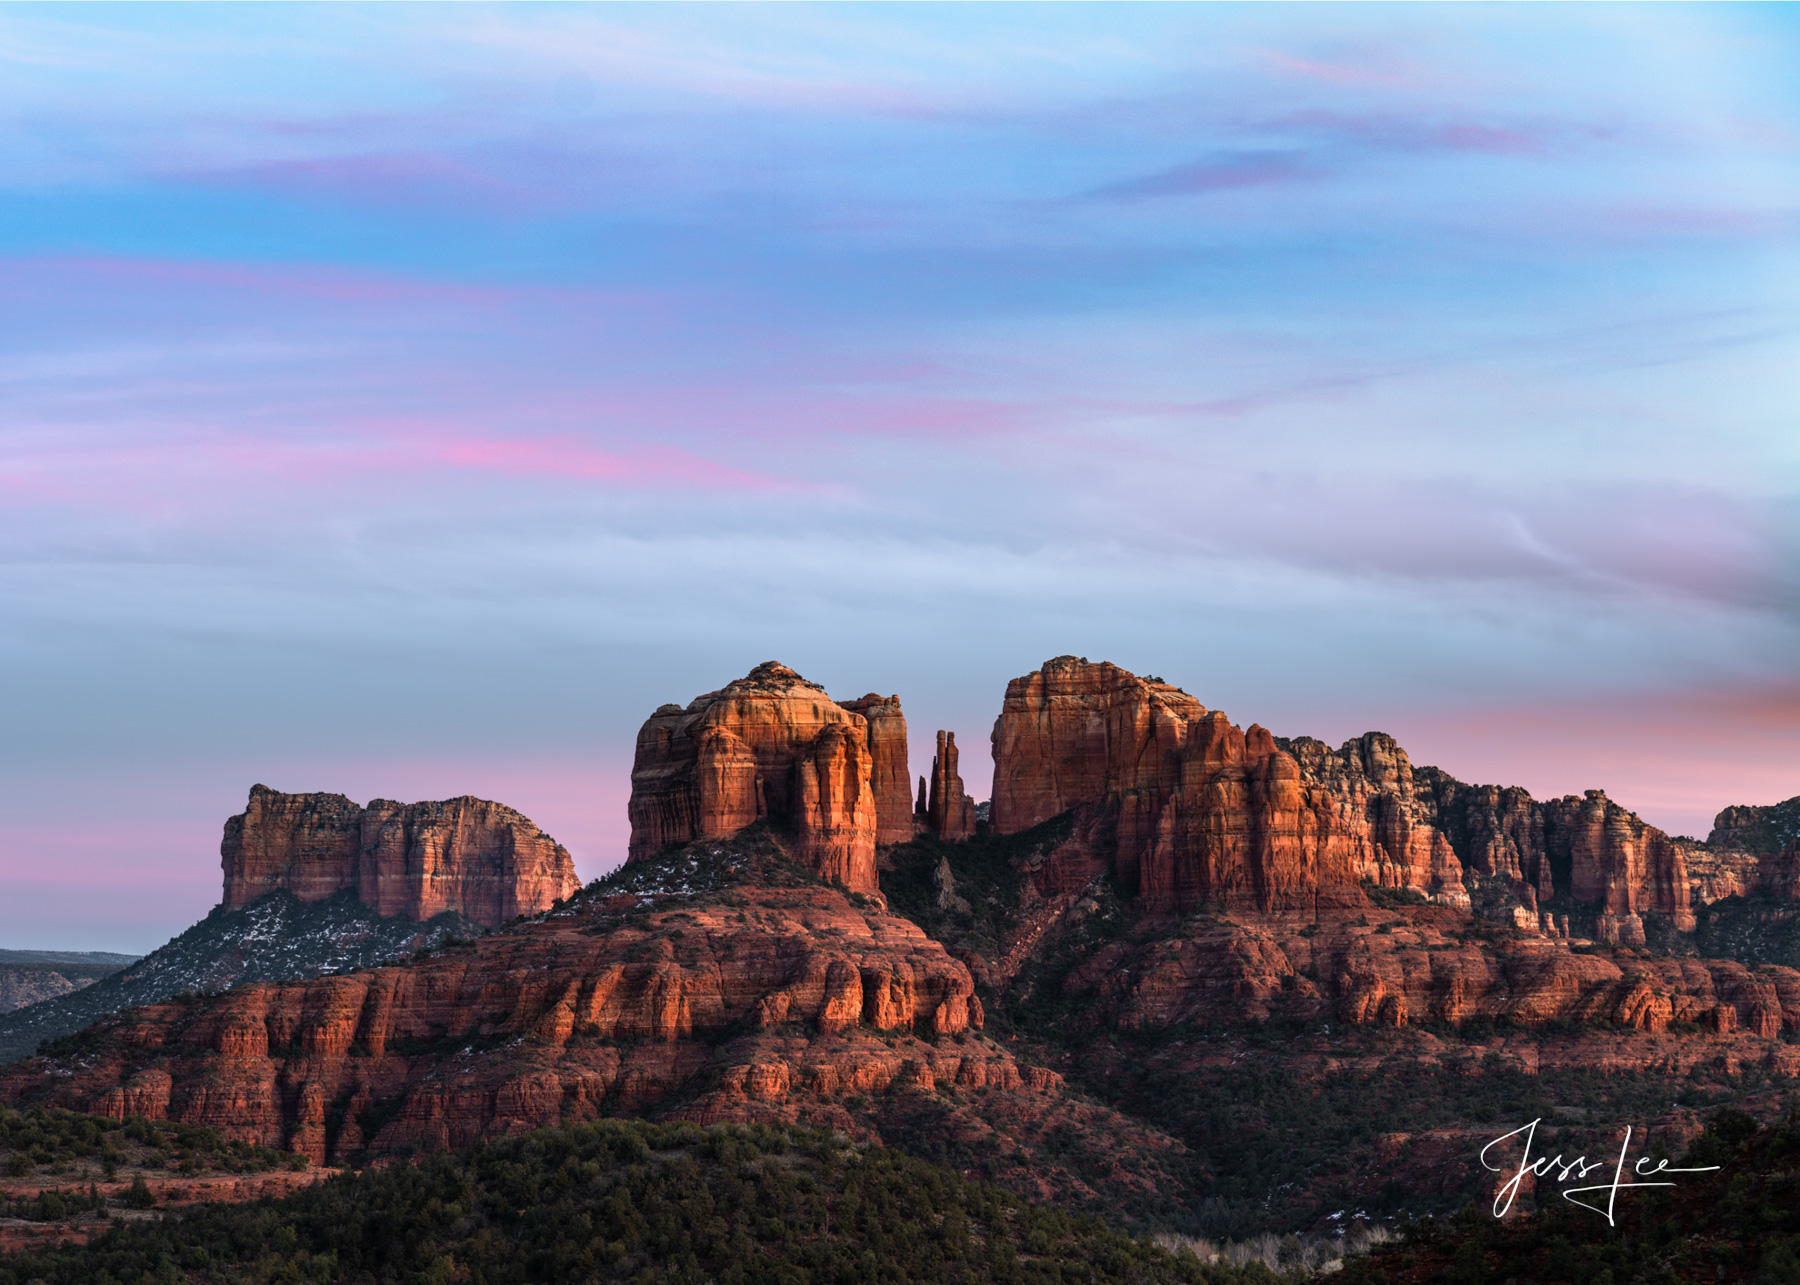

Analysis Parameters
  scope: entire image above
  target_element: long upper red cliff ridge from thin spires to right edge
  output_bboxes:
[994,657,1800,945]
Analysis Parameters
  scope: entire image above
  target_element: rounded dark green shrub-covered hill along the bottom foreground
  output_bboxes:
[0,1119,1278,1285]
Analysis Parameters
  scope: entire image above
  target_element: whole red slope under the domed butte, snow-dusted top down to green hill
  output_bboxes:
[0,828,1192,1220]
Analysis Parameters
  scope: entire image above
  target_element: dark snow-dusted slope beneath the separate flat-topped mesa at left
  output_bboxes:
[0,891,484,1065]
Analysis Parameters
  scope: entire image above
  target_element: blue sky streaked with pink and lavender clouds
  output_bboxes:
[0,4,1800,950]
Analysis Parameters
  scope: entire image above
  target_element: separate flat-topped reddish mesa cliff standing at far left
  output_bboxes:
[220,785,581,929]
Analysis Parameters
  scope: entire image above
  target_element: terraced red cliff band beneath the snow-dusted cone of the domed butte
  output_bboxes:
[0,845,1058,1161]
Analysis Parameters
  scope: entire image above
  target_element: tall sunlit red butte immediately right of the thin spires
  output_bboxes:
[994,657,1467,911]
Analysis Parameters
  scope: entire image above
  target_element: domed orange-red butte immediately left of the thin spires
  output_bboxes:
[628,660,889,893]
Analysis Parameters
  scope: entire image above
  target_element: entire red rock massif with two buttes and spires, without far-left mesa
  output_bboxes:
[0,657,1800,1220]
